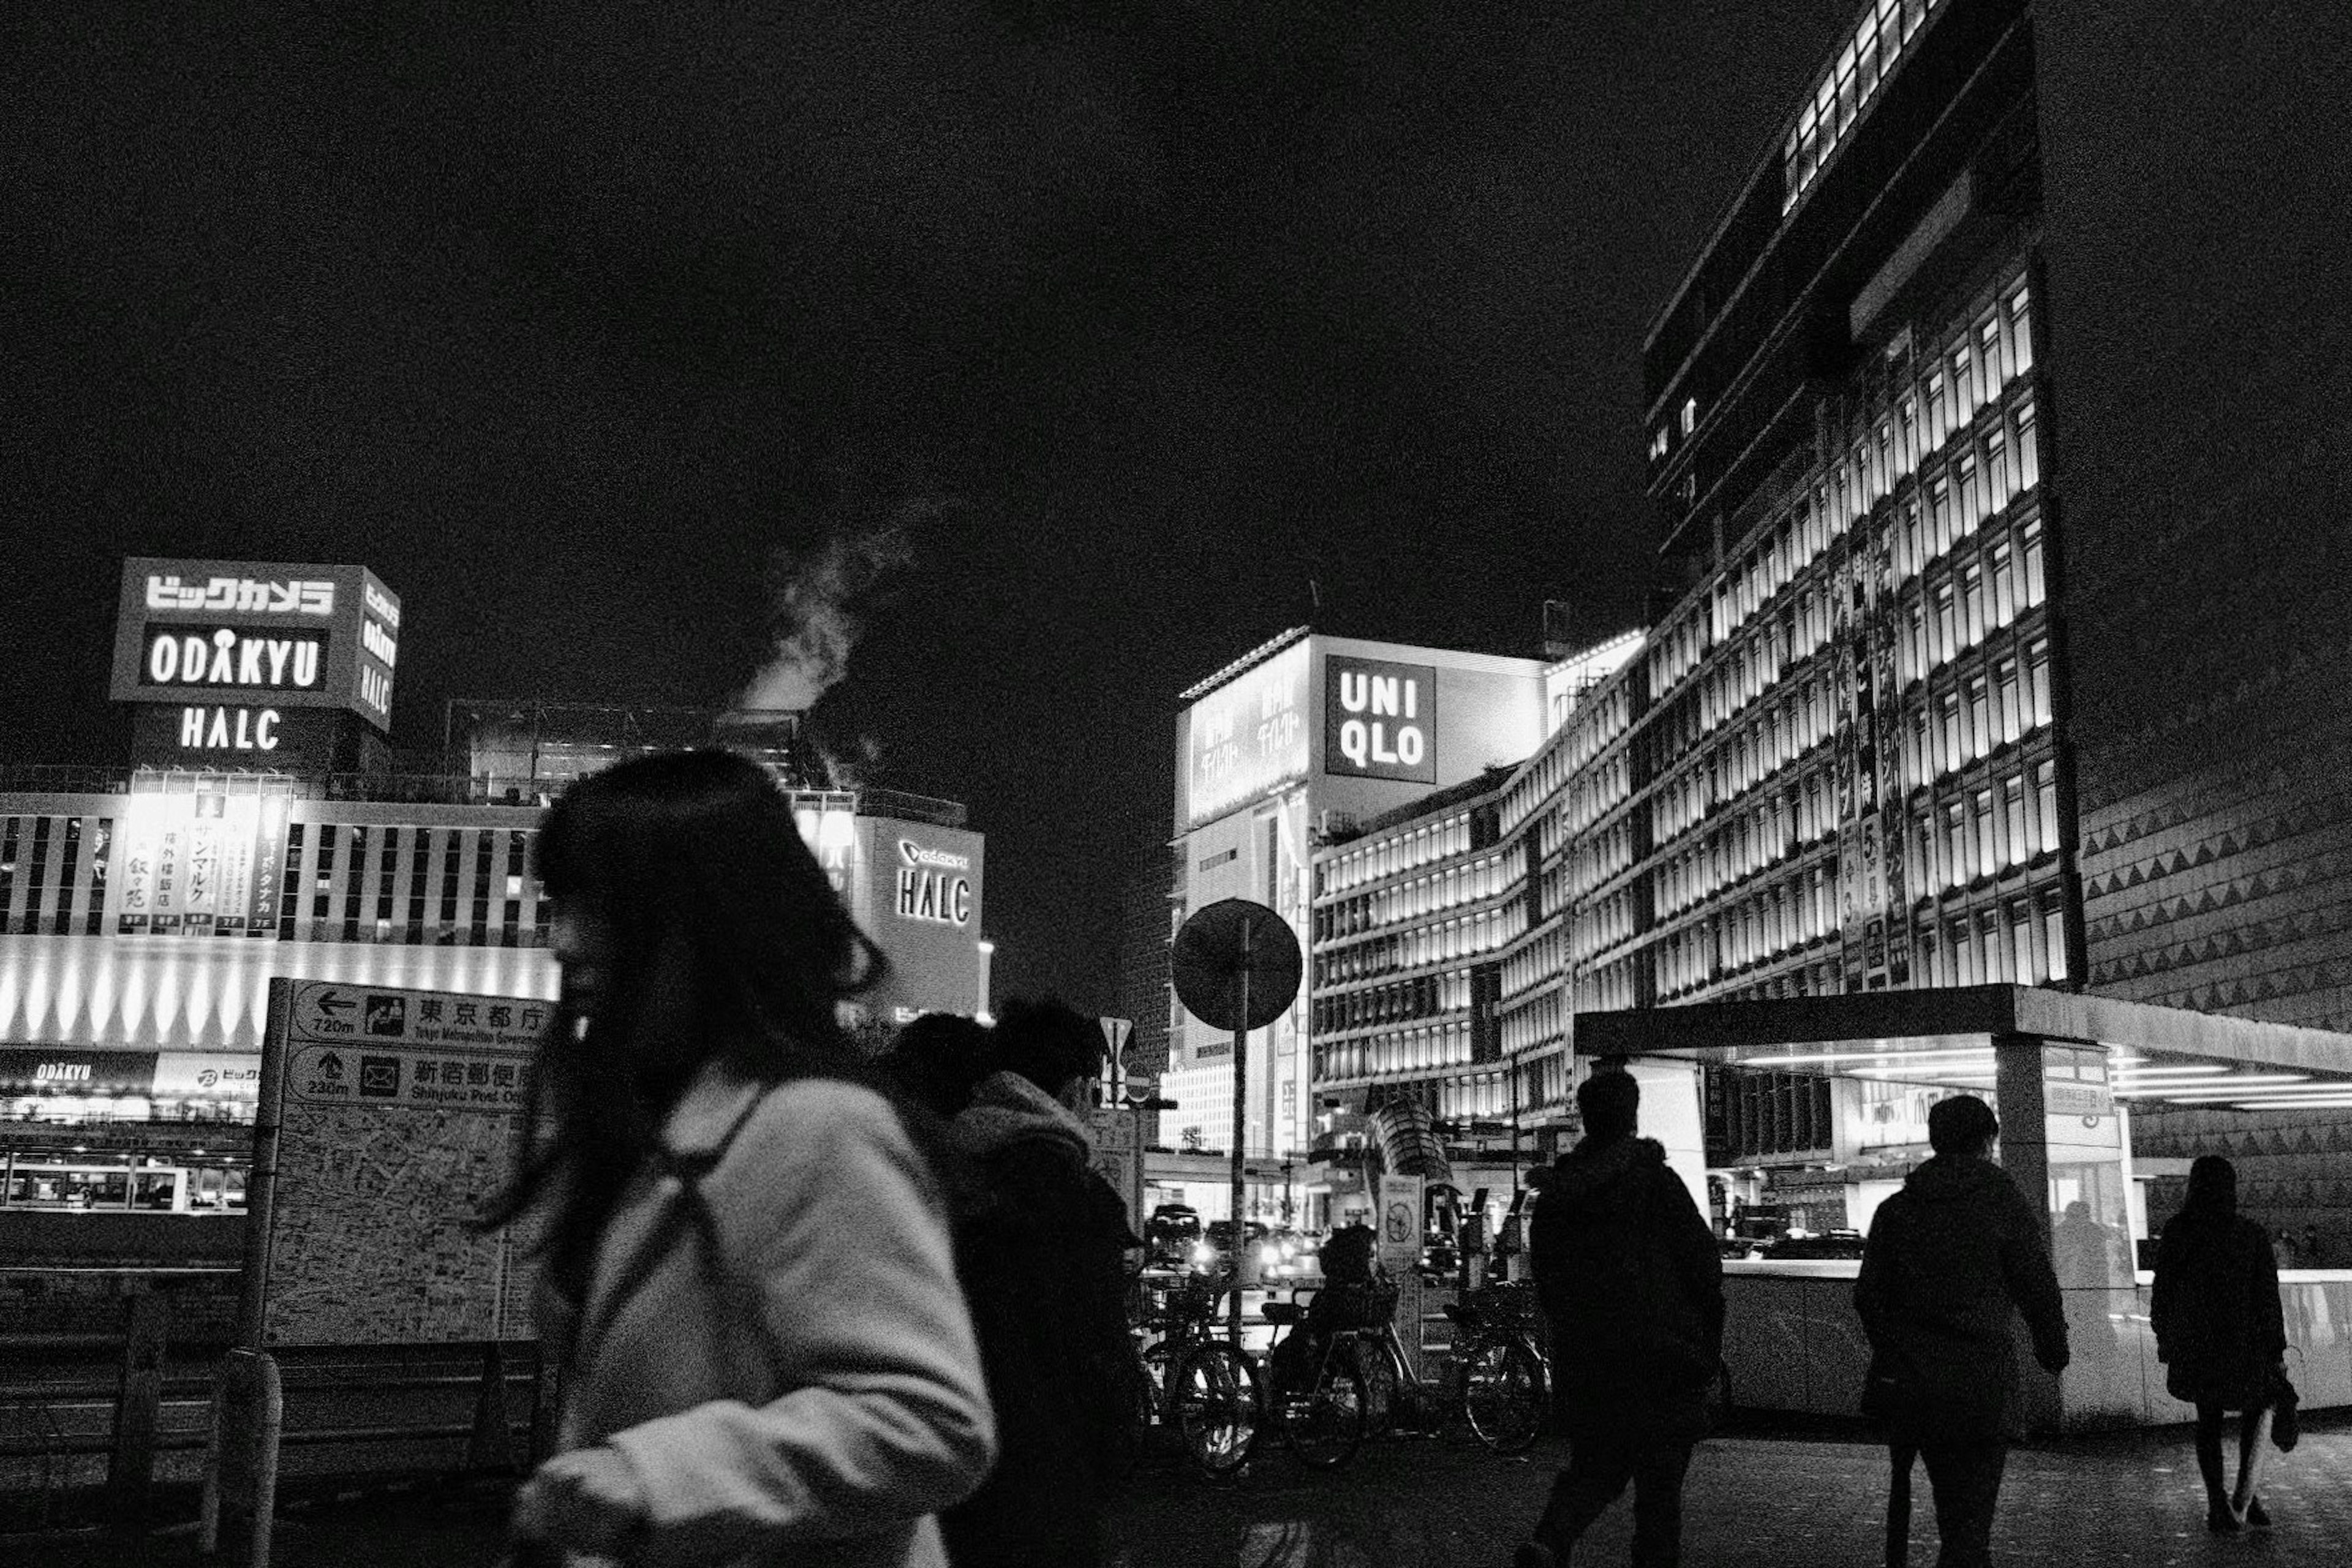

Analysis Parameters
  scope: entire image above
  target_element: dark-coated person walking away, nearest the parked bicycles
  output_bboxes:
[1512,1065,1724,1568]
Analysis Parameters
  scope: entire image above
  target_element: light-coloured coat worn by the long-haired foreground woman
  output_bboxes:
[545,1065,995,1568]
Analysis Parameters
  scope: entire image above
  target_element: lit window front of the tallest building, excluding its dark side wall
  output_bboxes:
[1627,0,2084,1189]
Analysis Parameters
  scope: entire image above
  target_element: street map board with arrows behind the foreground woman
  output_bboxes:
[249,980,552,1349]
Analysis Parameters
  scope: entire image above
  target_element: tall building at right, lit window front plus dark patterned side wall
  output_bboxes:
[1561,0,2352,1232]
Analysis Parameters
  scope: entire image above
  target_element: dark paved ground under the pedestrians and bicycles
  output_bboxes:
[18,1417,2352,1568]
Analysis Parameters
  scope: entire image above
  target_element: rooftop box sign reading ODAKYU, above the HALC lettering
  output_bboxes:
[110,557,400,750]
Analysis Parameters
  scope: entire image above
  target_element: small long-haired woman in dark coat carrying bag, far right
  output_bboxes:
[2147,1154,2286,1535]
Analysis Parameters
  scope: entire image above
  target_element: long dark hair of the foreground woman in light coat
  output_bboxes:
[482,750,887,1298]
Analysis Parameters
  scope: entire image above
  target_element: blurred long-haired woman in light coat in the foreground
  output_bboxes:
[487,752,995,1568]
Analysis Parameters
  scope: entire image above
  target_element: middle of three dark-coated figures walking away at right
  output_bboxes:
[1853,1096,2067,1568]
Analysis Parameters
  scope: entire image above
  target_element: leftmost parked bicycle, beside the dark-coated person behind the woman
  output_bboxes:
[1129,1274,1258,1479]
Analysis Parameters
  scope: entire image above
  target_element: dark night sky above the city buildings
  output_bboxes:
[13,0,1853,1011]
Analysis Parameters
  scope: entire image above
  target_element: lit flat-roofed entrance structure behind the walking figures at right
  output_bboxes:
[1576,985,2352,1431]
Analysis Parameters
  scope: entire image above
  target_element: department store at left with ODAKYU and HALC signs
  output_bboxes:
[0,559,988,1211]
